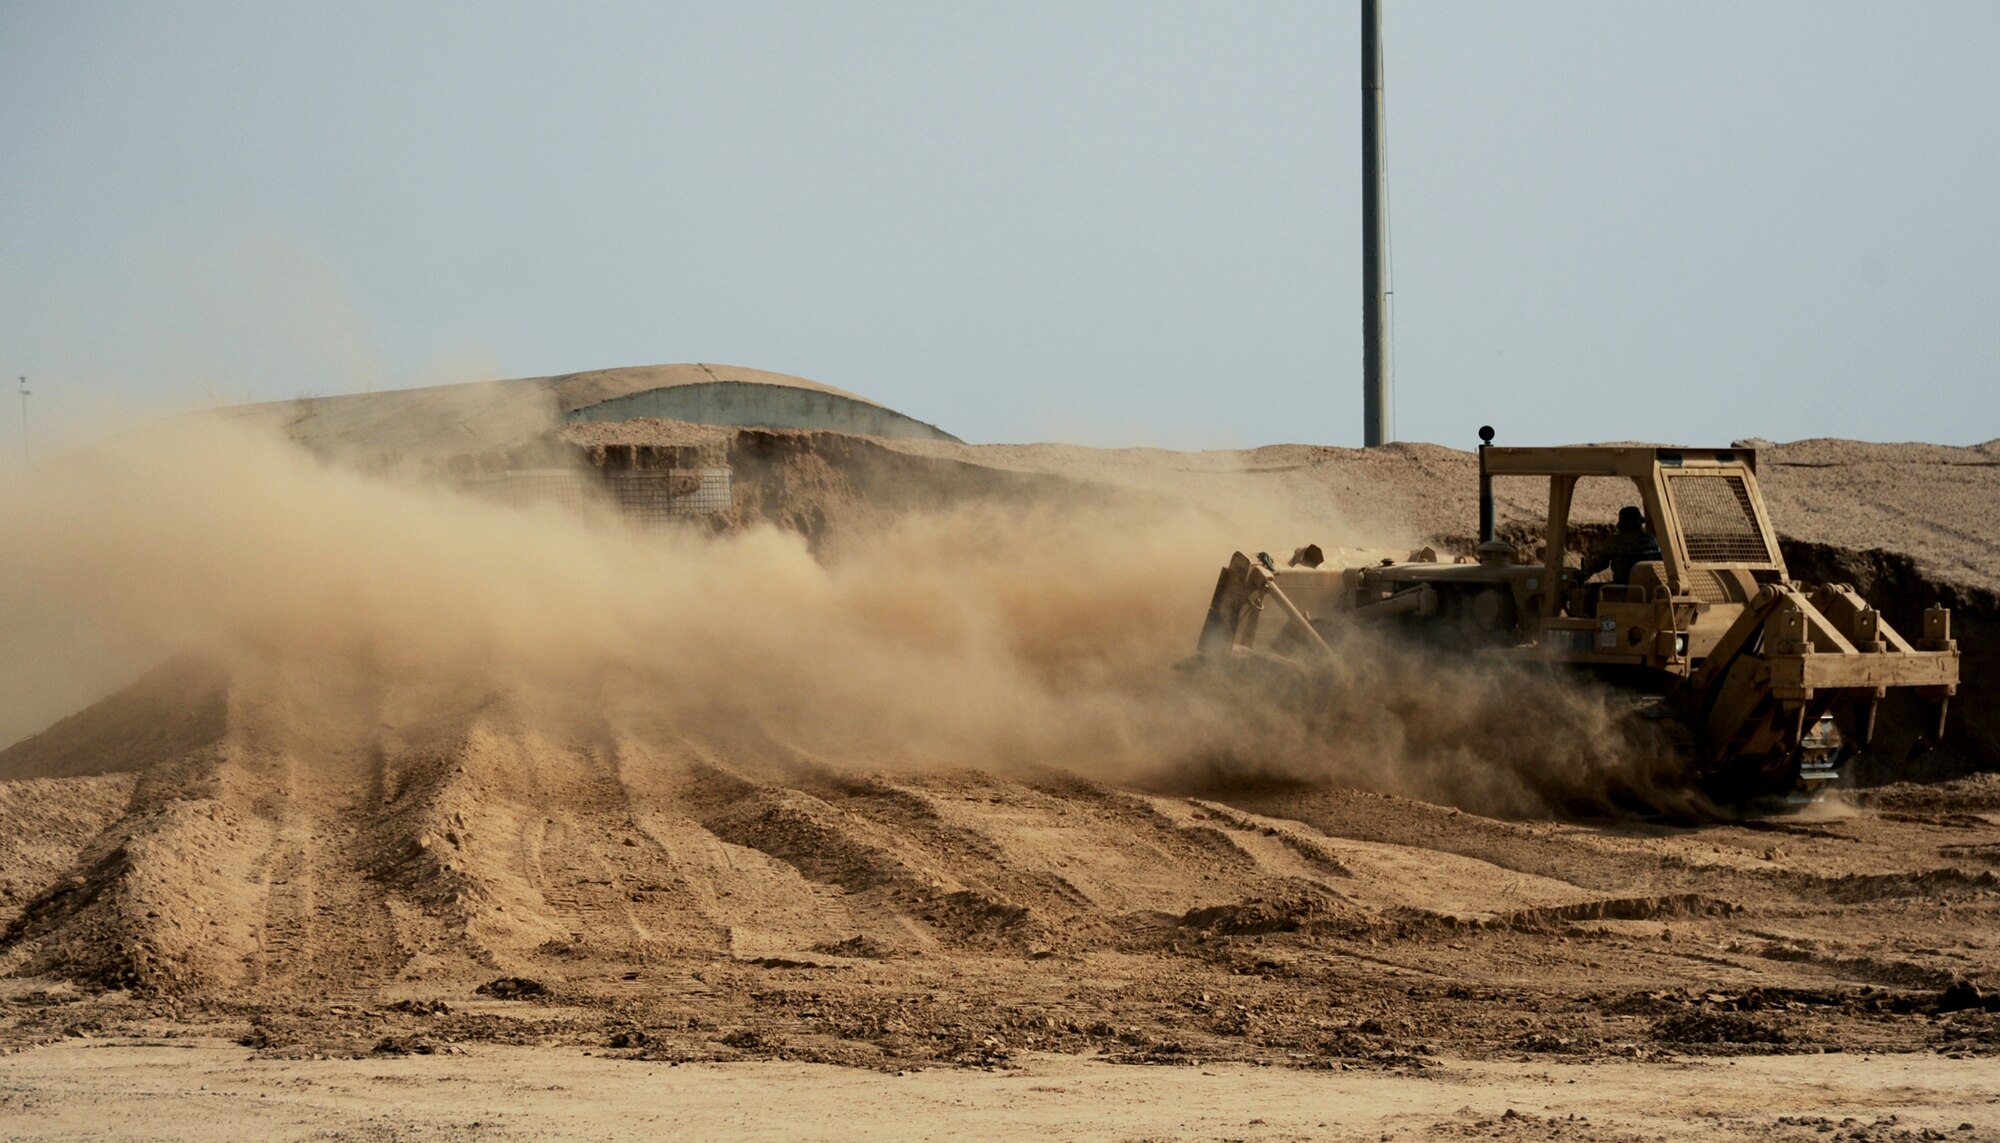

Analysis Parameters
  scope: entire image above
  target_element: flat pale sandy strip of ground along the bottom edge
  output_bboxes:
[0,1039,2000,1143]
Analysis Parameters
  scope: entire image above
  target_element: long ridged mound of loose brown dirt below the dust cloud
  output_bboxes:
[6,663,1608,995]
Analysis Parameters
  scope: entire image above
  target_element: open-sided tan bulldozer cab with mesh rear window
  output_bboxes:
[1480,446,1786,619]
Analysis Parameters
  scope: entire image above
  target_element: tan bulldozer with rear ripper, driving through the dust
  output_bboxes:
[1194,426,1958,803]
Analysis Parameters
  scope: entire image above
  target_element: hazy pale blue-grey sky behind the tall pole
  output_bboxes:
[0,0,2000,452]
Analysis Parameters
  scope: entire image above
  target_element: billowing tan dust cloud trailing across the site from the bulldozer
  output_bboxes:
[0,422,1672,813]
